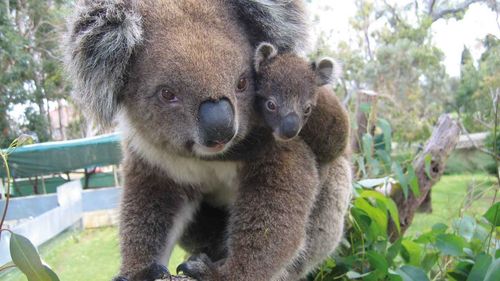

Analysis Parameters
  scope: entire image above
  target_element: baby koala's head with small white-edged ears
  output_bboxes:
[254,42,340,141]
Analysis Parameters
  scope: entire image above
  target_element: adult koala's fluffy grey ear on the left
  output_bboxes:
[66,0,142,127]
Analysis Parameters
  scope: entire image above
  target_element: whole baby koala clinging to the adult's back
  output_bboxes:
[254,42,349,162]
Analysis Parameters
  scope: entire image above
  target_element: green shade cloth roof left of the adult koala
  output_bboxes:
[0,133,122,178]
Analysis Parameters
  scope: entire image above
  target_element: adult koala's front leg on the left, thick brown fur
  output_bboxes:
[115,154,198,281]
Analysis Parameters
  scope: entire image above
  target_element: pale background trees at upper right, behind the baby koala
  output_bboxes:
[312,0,500,144]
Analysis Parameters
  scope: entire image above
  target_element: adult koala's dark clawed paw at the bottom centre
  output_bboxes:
[177,254,222,281]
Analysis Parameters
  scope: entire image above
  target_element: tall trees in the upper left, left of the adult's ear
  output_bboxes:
[0,0,69,144]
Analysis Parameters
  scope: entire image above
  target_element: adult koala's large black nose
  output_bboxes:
[198,99,236,147]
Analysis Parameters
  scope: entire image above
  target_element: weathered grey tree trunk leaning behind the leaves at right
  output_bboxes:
[389,114,460,240]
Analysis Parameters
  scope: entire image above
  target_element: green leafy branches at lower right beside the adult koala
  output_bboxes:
[309,119,500,281]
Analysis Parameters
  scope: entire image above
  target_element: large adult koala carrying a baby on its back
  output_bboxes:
[67,0,350,281]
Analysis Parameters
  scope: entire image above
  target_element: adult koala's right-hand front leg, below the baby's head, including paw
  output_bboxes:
[181,140,318,281]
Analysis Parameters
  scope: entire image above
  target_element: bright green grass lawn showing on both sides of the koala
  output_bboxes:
[0,174,494,281]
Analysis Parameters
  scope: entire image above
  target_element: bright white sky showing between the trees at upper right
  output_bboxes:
[309,0,500,76]
